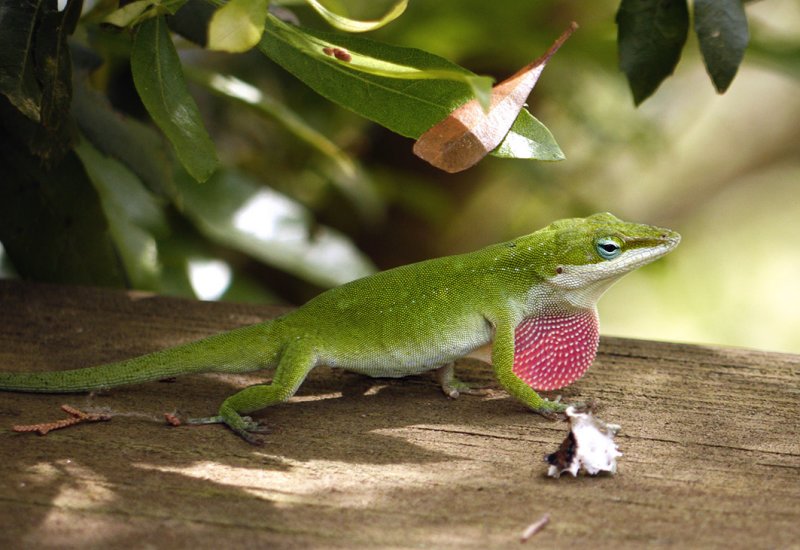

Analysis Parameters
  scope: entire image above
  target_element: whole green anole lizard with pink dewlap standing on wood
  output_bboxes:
[0,214,680,443]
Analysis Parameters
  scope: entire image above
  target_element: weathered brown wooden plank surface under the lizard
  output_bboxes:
[0,281,800,548]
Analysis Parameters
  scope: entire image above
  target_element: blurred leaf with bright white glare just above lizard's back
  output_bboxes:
[176,170,374,287]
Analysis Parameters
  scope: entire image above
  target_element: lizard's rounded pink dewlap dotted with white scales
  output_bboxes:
[513,310,600,390]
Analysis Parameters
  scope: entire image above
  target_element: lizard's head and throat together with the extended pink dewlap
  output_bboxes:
[506,214,680,390]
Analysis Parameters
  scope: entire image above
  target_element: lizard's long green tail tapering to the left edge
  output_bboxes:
[0,322,282,393]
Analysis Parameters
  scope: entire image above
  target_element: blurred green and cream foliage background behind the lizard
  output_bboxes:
[0,0,800,352]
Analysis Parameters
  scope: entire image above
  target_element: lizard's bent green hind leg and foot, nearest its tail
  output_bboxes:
[188,340,317,445]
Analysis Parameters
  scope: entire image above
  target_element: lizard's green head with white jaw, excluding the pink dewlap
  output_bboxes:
[537,213,681,307]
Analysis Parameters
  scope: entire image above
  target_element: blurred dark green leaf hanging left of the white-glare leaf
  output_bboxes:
[75,141,167,290]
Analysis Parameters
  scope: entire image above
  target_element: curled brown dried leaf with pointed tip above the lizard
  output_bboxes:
[414,22,578,174]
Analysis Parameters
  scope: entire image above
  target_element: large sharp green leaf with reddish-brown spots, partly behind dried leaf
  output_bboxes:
[259,16,557,158]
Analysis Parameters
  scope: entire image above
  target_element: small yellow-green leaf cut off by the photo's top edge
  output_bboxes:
[208,0,269,53]
